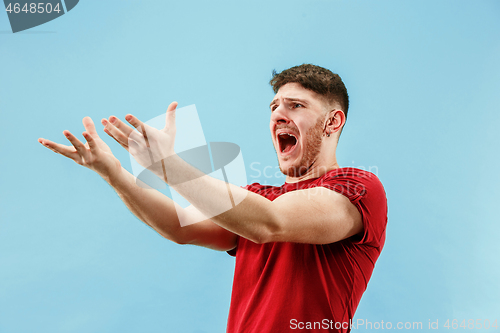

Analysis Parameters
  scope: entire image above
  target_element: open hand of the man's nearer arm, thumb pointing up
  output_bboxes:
[101,102,177,182]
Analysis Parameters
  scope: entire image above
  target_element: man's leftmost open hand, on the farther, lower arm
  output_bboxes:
[38,117,121,180]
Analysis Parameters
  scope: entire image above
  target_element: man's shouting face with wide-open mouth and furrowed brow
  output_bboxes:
[270,83,326,177]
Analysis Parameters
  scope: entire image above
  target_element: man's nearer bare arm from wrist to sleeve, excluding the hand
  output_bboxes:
[165,155,363,244]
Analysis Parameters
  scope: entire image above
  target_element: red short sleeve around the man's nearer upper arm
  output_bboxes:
[319,168,387,247]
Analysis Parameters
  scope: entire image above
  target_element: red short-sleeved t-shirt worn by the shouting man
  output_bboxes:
[227,168,387,333]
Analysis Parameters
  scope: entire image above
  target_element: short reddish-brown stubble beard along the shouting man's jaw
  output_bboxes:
[280,117,324,177]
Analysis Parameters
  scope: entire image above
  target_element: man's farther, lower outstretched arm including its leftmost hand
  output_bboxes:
[38,117,236,251]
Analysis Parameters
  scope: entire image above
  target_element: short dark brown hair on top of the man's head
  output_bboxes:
[269,64,349,118]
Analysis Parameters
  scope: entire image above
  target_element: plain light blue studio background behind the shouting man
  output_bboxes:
[0,0,500,333]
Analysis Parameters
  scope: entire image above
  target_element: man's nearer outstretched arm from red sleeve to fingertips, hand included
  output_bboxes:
[103,102,363,244]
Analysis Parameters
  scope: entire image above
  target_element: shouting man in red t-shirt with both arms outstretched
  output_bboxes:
[39,65,387,333]
